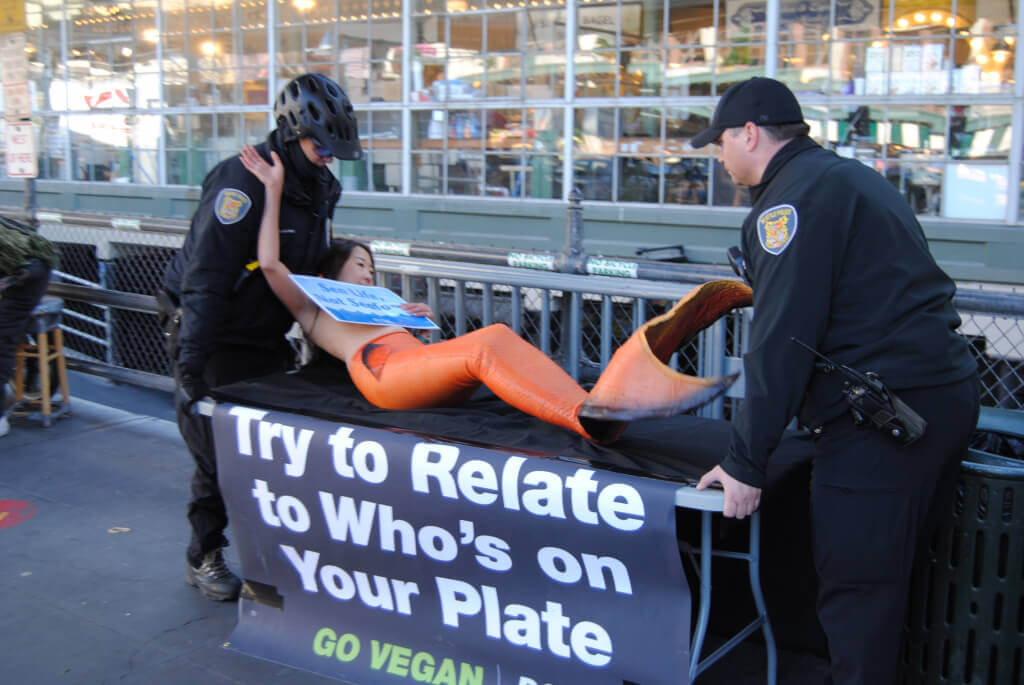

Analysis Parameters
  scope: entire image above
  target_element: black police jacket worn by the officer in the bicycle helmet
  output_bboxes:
[164,131,341,376]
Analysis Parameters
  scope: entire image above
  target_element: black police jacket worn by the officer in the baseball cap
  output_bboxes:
[722,136,977,487]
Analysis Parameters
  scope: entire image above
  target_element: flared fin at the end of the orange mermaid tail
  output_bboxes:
[578,281,754,421]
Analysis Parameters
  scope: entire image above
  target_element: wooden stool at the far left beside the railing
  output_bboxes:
[10,295,71,427]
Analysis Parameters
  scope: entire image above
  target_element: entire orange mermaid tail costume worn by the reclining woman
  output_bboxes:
[348,282,750,442]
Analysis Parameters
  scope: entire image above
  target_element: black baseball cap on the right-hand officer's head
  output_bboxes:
[690,76,804,148]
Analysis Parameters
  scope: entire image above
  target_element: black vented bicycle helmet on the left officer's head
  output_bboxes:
[273,74,362,160]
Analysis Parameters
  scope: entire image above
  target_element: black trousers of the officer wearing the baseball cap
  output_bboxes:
[811,376,980,685]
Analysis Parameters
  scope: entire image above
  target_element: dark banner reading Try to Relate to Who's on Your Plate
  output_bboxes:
[213,404,690,685]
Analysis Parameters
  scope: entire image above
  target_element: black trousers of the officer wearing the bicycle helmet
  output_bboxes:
[158,297,292,566]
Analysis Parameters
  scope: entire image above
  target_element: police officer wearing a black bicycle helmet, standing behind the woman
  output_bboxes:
[158,74,362,600]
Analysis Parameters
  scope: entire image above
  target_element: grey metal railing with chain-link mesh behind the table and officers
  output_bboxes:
[2,200,1024,409]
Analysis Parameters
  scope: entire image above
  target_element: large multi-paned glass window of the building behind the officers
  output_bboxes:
[6,0,1024,220]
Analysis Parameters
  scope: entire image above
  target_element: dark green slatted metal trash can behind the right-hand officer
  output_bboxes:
[903,410,1024,685]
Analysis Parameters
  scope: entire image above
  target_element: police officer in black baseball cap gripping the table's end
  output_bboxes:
[691,78,979,685]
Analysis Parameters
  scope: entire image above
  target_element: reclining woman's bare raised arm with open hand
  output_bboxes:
[239,145,316,330]
